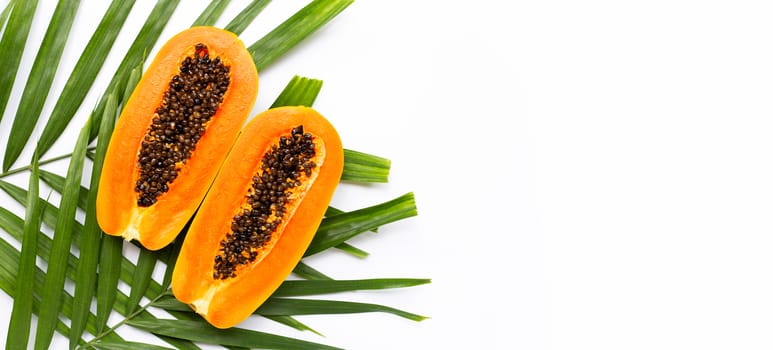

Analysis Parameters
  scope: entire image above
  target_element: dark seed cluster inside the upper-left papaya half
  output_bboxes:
[134,43,231,207]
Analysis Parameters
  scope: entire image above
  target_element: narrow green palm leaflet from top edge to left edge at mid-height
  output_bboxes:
[3,0,80,170]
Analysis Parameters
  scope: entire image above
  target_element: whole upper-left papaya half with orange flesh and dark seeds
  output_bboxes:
[96,27,258,250]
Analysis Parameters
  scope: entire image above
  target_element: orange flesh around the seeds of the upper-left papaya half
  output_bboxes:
[97,27,258,250]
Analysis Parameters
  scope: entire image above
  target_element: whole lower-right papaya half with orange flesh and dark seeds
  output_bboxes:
[172,107,344,328]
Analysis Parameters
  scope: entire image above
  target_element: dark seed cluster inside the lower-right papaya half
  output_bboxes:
[213,125,317,279]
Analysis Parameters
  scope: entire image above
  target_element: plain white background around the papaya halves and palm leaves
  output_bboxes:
[0,0,773,349]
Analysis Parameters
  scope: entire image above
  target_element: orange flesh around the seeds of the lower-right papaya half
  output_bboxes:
[172,107,343,328]
